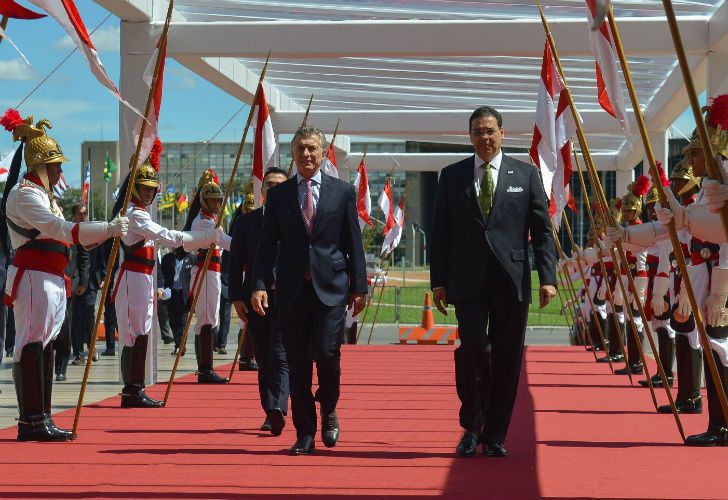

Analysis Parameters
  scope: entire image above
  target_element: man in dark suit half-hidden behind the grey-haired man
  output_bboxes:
[232,168,289,436]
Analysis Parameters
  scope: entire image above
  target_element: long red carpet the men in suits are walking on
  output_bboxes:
[0,346,728,499]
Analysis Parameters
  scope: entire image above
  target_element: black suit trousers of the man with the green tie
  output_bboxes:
[455,260,528,443]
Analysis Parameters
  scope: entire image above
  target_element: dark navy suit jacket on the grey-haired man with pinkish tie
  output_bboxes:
[253,172,367,308]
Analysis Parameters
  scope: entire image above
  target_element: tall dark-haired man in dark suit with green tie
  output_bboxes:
[430,106,556,457]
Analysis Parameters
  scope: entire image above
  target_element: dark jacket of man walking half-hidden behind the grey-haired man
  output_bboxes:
[227,208,264,302]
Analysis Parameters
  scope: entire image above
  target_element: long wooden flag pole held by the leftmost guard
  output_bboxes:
[72,0,174,439]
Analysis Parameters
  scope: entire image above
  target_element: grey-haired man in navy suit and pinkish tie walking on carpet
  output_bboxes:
[252,126,367,455]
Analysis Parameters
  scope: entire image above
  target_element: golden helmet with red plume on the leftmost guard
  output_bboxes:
[0,109,69,191]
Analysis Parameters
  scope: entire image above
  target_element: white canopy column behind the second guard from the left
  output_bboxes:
[119,21,159,384]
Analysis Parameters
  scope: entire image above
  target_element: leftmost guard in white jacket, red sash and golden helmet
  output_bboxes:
[0,110,128,441]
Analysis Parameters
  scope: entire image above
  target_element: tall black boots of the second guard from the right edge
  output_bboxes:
[657,334,703,414]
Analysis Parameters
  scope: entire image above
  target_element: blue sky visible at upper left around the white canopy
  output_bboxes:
[0,0,247,186]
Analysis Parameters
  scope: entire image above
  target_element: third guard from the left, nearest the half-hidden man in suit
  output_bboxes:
[185,169,230,384]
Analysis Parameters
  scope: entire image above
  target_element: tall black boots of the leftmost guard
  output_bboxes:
[13,342,71,441]
